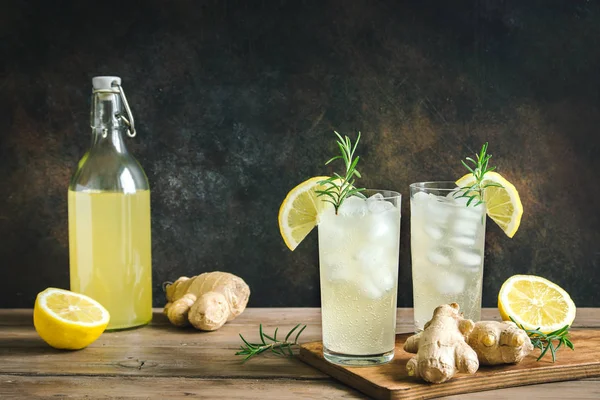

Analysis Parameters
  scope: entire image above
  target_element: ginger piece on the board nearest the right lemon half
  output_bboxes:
[467,321,533,365]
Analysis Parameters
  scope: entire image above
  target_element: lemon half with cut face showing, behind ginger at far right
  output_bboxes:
[498,275,576,333]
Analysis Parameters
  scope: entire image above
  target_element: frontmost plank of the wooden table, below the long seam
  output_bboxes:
[0,375,600,400]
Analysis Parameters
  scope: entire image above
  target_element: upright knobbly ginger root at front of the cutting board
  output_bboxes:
[404,303,479,383]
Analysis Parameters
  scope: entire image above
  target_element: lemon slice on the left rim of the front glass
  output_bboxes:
[279,176,329,251]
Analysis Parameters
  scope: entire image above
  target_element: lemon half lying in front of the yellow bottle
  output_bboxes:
[33,288,110,350]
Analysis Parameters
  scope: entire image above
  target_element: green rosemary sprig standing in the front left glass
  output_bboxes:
[316,131,365,214]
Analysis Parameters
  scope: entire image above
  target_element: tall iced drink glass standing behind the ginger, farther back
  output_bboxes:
[410,182,486,331]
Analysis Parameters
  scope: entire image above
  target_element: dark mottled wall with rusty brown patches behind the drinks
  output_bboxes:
[0,0,600,307]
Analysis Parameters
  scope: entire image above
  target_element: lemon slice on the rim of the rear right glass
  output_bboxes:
[456,171,523,238]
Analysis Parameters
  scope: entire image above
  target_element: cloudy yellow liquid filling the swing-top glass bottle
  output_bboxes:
[69,190,152,329]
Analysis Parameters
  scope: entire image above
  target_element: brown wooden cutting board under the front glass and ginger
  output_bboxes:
[299,330,600,400]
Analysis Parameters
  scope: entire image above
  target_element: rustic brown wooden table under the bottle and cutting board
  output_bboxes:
[0,308,600,400]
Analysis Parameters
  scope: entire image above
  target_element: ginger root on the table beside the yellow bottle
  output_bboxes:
[164,271,250,331]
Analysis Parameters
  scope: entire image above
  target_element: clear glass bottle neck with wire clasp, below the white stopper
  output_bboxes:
[90,91,127,153]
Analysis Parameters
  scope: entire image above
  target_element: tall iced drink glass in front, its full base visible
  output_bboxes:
[318,190,401,366]
